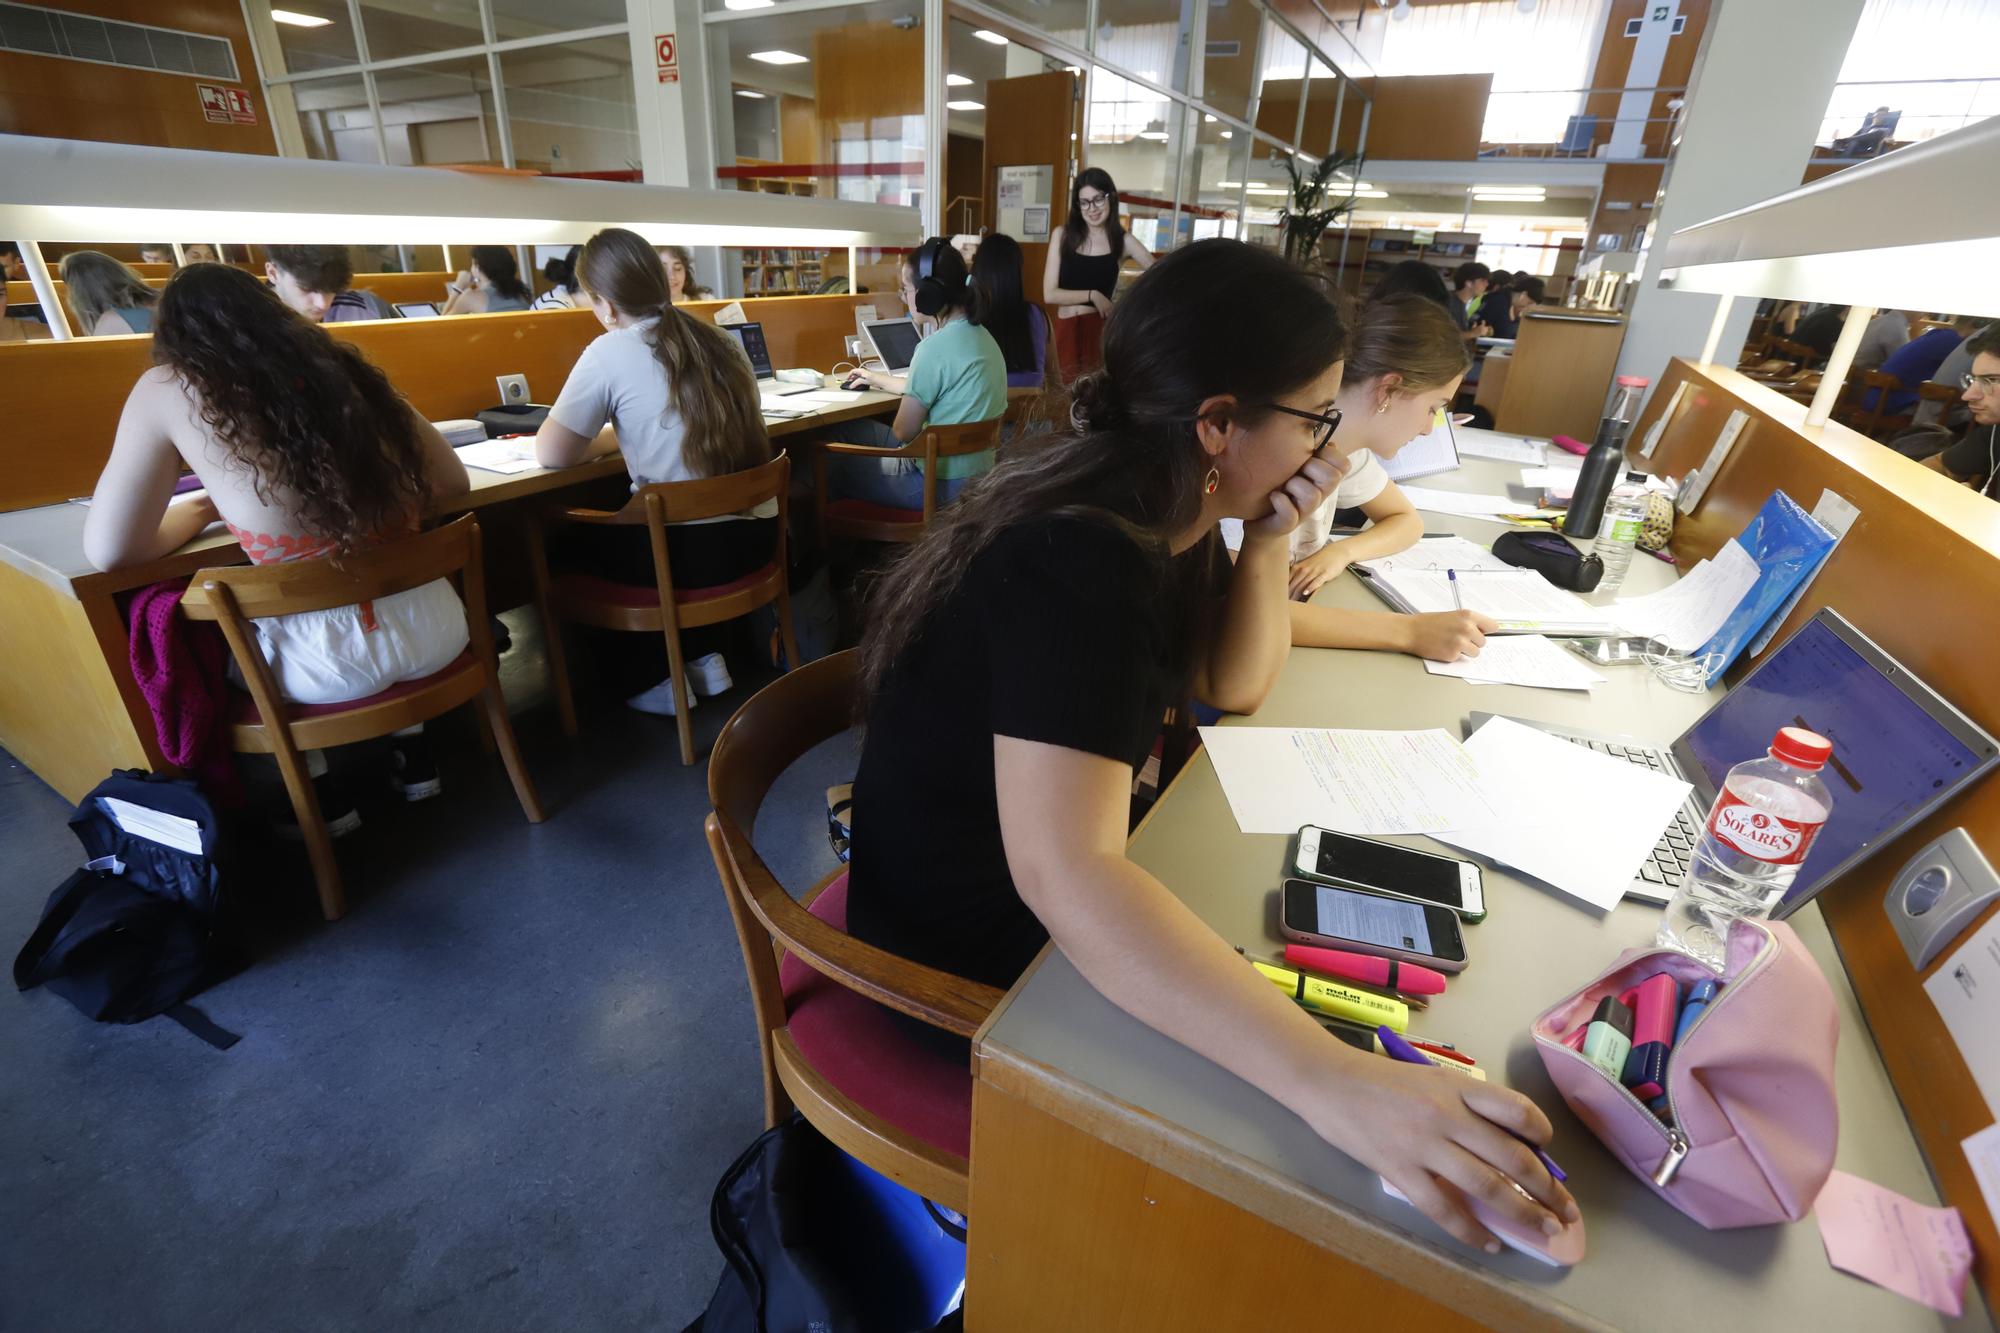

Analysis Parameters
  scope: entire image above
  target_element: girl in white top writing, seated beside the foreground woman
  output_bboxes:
[1222,296,1494,662]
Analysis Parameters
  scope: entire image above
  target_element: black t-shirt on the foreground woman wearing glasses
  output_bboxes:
[848,516,1230,987]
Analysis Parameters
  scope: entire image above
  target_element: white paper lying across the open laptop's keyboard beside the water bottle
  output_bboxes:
[1436,716,1690,911]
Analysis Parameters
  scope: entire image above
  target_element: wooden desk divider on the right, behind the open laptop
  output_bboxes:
[1632,358,2000,1309]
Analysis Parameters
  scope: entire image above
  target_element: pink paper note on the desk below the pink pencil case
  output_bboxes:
[1812,1171,1972,1317]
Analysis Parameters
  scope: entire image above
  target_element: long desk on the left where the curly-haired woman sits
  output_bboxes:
[0,394,900,801]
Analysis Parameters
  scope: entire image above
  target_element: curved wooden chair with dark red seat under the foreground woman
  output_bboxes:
[706,650,1002,1211]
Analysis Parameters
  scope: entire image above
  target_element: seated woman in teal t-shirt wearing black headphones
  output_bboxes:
[826,236,1006,508]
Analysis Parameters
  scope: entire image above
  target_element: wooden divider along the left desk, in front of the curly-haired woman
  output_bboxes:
[0,290,884,512]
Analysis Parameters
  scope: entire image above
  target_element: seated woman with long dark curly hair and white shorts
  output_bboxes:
[84,264,470,820]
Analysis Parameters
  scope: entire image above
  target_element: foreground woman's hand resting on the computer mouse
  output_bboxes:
[1306,1053,1582,1255]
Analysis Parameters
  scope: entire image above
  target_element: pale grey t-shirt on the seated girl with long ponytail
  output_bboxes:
[548,318,778,522]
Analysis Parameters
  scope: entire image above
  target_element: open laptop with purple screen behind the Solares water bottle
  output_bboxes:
[1472,608,2000,919]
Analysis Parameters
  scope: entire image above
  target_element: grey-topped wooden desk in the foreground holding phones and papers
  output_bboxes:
[966,440,1986,1333]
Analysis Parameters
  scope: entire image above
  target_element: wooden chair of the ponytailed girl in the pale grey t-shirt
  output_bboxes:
[528,450,798,765]
